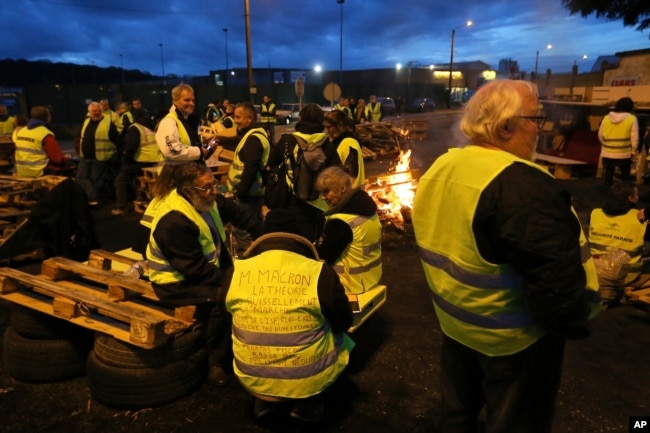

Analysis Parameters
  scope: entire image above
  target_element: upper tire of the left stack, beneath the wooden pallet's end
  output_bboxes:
[9,305,93,341]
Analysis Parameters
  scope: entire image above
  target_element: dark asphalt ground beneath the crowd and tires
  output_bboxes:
[0,111,650,433]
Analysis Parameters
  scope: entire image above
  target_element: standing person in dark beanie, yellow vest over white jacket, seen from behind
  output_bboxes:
[598,97,639,186]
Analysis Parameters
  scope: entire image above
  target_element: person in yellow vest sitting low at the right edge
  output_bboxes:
[589,182,650,309]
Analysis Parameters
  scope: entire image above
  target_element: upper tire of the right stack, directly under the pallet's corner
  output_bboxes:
[93,328,205,368]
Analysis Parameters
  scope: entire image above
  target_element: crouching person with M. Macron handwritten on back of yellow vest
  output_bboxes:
[226,209,354,422]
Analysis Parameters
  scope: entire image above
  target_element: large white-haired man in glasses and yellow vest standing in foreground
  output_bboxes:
[412,80,600,433]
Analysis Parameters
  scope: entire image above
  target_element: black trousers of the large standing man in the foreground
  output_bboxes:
[439,335,565,433]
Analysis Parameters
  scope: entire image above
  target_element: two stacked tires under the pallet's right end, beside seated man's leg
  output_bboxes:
[87,328,208,409]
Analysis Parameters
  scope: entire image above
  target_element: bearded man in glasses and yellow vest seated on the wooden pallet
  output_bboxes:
[146,161,262,386]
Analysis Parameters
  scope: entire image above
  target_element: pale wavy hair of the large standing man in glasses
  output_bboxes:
[460,80,537,143]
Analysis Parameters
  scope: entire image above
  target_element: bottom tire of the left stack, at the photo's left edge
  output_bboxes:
[2,326,91,383]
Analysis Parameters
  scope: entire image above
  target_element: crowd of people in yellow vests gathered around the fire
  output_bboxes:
[5,80,650,433]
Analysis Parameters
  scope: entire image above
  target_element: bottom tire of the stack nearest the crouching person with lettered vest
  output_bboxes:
[87,349,208,409]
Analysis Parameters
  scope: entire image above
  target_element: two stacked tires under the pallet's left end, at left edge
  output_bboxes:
[3,306,93,383]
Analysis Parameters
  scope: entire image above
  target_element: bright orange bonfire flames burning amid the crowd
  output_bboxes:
[366,149,419,231]
